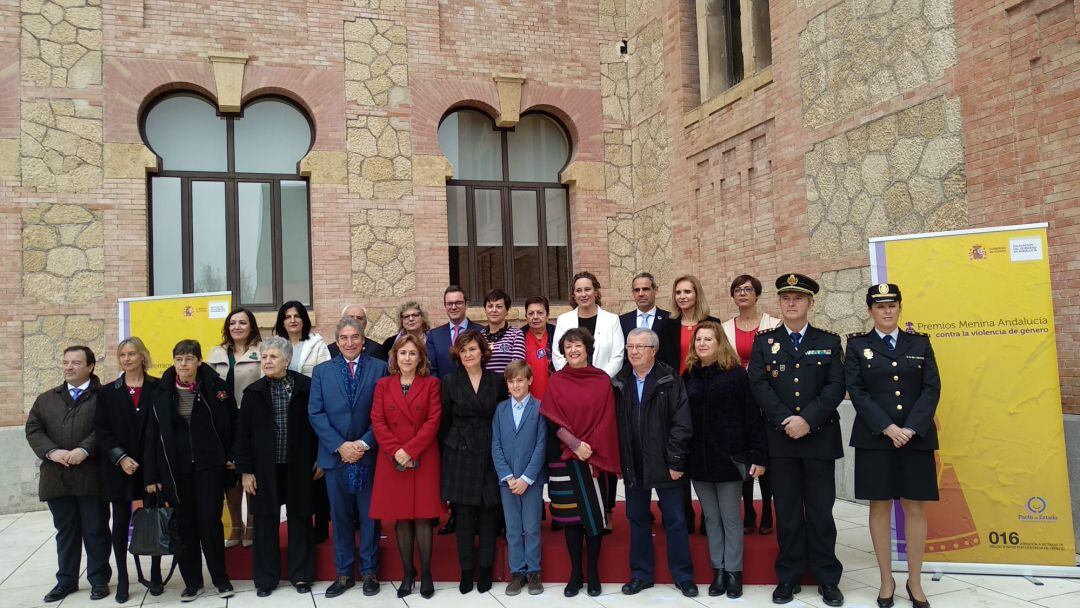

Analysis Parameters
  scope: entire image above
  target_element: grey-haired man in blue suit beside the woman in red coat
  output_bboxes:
[308,316,387,597]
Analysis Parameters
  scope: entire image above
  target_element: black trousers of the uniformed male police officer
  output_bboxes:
[769,458,843,585]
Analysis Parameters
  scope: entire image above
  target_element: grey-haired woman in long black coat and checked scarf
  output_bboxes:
[237,336,323,597]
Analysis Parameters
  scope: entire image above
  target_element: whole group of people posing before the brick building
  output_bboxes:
[26,272,941,608]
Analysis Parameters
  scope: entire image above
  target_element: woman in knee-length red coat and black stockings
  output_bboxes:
[370,334,446,598]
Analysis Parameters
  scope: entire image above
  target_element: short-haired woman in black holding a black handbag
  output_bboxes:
[143,340,237,602]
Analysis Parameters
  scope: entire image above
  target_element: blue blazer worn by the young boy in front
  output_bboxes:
[491,395,548,486]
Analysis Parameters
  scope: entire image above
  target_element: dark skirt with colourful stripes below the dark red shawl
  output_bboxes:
[548,459,605,537]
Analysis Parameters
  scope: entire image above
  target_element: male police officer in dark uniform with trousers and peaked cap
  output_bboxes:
[746,273,845,606]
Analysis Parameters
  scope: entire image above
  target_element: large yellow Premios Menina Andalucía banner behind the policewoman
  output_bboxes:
[869,225,1076,566]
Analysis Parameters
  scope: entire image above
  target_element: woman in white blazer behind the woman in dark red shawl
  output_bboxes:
[551,271,626,377]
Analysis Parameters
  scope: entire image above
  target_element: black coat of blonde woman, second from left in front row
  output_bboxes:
[94,374,159,502]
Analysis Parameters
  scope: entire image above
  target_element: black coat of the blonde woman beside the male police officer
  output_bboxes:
[683,364,767,483]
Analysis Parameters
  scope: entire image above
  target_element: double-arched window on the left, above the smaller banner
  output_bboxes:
[143,93,314,309]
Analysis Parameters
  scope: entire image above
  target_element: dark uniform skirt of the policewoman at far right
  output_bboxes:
[855,447,937,500]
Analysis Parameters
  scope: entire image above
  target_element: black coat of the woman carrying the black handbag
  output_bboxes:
[143,363,237,502]
